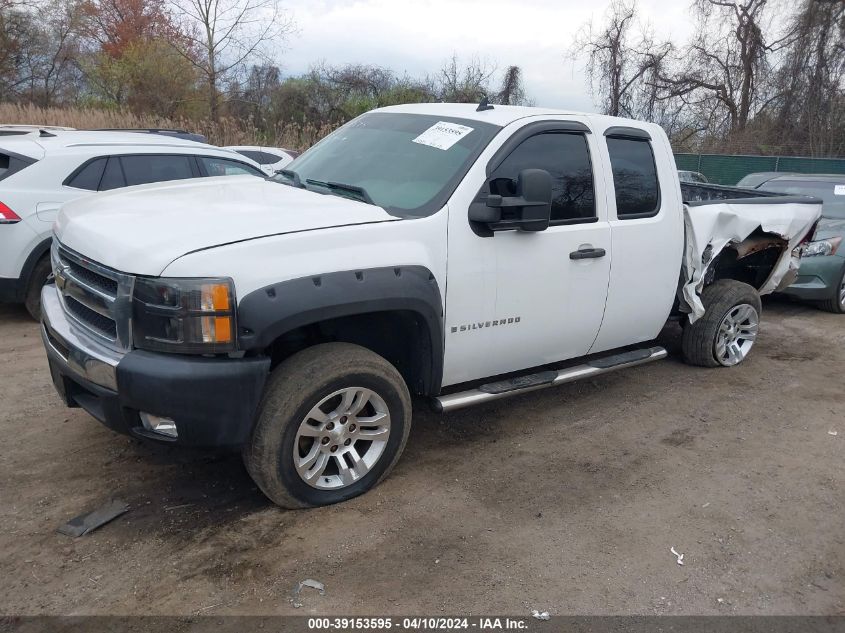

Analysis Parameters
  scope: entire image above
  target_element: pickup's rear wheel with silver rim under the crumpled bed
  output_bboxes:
[682,279,762,367]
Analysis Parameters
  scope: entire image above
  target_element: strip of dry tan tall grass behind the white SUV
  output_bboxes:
[0,103,337,151]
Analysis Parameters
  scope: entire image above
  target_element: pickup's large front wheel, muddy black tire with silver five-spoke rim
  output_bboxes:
[243,343,411,508]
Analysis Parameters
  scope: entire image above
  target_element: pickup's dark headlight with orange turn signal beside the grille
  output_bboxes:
[132,277,235,354]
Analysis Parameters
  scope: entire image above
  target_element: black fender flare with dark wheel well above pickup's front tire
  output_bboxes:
[238,266,444,395]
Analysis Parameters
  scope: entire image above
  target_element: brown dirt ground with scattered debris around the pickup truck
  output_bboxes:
[0,301,845,615]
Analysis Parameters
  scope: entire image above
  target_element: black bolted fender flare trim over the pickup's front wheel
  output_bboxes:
[238,266,445,393]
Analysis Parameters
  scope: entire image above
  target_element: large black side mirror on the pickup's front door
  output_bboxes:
[469,169,552,231]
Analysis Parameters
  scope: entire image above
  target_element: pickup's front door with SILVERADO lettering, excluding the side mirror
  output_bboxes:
[444,121,611,384]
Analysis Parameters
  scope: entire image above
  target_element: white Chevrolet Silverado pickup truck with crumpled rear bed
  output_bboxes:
[42,104,820,507]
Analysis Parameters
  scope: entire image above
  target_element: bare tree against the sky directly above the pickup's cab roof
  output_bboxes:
[570,0,672,120]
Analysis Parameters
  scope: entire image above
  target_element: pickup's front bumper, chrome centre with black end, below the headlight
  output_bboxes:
[41,284,270,447]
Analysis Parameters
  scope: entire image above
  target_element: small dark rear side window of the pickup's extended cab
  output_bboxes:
[605,128,660,220]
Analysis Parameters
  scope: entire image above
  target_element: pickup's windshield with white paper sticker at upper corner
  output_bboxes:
[272,112,501,217]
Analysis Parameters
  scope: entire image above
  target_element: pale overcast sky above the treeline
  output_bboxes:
[279,0,691,110]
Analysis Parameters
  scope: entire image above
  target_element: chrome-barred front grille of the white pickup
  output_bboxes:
[51,239,134,351]
